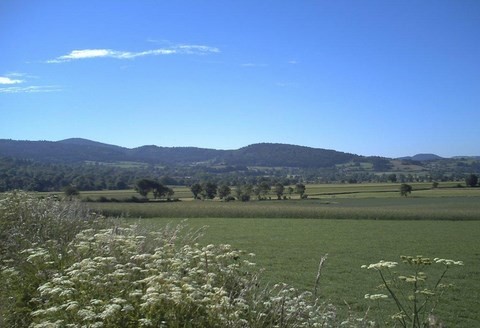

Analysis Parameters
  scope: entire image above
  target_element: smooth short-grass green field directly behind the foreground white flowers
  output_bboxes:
[135,218,480,327]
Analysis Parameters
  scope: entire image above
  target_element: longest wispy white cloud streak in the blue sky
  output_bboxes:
[47,45,220,64]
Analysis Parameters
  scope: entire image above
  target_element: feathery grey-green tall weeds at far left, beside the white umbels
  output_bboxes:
[0,192,107,327]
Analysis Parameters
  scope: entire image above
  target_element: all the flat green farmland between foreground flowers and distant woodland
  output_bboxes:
[35,184,480,327]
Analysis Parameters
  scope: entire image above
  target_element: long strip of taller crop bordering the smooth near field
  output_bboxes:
[89,195,480,220]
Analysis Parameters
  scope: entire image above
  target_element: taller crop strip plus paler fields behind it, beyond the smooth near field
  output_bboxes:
[77,183,480,220]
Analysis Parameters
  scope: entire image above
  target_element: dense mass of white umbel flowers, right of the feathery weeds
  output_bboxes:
[25,226,356,328]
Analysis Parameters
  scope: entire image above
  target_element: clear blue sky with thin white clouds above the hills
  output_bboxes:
[0,0,480,157]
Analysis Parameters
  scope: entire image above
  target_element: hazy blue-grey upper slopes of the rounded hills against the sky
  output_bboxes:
[0,138,364,167]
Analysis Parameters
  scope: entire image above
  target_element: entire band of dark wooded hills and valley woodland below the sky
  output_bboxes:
[0,139,480,192]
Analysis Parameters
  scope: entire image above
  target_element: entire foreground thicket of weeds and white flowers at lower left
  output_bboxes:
[0,193,372,328]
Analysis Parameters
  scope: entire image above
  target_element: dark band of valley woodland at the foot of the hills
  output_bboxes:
[0,157,480,193]
